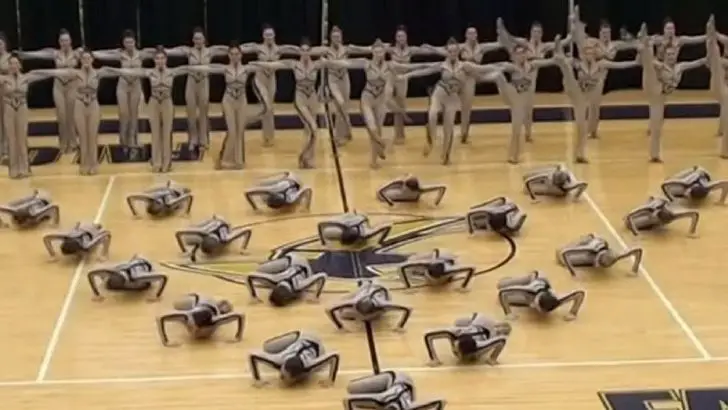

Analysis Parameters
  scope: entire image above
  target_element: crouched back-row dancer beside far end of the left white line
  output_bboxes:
[126,181,194,217]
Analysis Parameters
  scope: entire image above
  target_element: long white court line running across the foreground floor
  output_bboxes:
[0,357,728,387]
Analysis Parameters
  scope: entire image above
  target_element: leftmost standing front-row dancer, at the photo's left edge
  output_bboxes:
[0,54,67,179]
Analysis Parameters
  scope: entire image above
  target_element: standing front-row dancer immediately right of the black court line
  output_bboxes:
[324,39,432,168]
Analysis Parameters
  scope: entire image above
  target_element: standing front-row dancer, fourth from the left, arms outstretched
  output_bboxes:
[183,43,260,169]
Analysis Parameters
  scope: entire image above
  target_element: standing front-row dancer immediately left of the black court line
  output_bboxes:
[250,39,328,169]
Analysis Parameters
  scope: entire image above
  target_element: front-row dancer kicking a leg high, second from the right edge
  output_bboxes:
[638,23,707,162]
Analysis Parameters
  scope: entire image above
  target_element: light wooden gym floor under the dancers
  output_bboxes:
[0,93,728,410]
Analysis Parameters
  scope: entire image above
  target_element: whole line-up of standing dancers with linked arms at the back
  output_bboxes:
[0,8,728,178]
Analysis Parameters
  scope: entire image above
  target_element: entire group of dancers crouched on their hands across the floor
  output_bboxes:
[0,165,728,409]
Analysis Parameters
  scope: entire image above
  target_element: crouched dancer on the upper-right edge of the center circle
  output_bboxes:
[465,196,528,235]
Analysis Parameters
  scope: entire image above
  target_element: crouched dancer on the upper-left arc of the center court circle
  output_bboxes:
[175,215,253,262]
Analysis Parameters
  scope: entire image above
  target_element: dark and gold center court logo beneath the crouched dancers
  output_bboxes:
[162,213,516,293]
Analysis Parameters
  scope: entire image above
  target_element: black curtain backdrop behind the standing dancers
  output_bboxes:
[0,0,728,108]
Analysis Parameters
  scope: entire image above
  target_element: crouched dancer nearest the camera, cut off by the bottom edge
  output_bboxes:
[344,370,446,410]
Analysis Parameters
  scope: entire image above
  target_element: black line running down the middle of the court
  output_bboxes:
[321,70,381,374]
